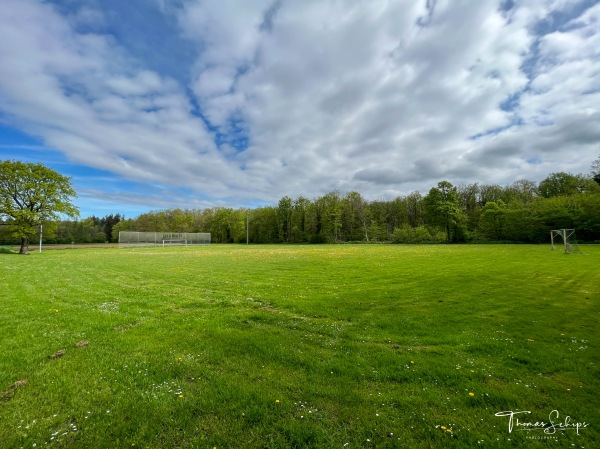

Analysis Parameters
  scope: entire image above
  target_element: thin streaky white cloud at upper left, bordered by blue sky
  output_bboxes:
[0,1,247,195]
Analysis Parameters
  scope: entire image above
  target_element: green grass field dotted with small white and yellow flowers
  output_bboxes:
[0,245,600,449]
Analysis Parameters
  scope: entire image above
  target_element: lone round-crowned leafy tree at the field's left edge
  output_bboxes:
[0,161,79,254]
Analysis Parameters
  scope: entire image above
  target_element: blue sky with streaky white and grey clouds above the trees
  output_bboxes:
[0,0,600,218]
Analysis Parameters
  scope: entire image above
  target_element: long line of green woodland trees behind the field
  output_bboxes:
[0,165,600,248]
